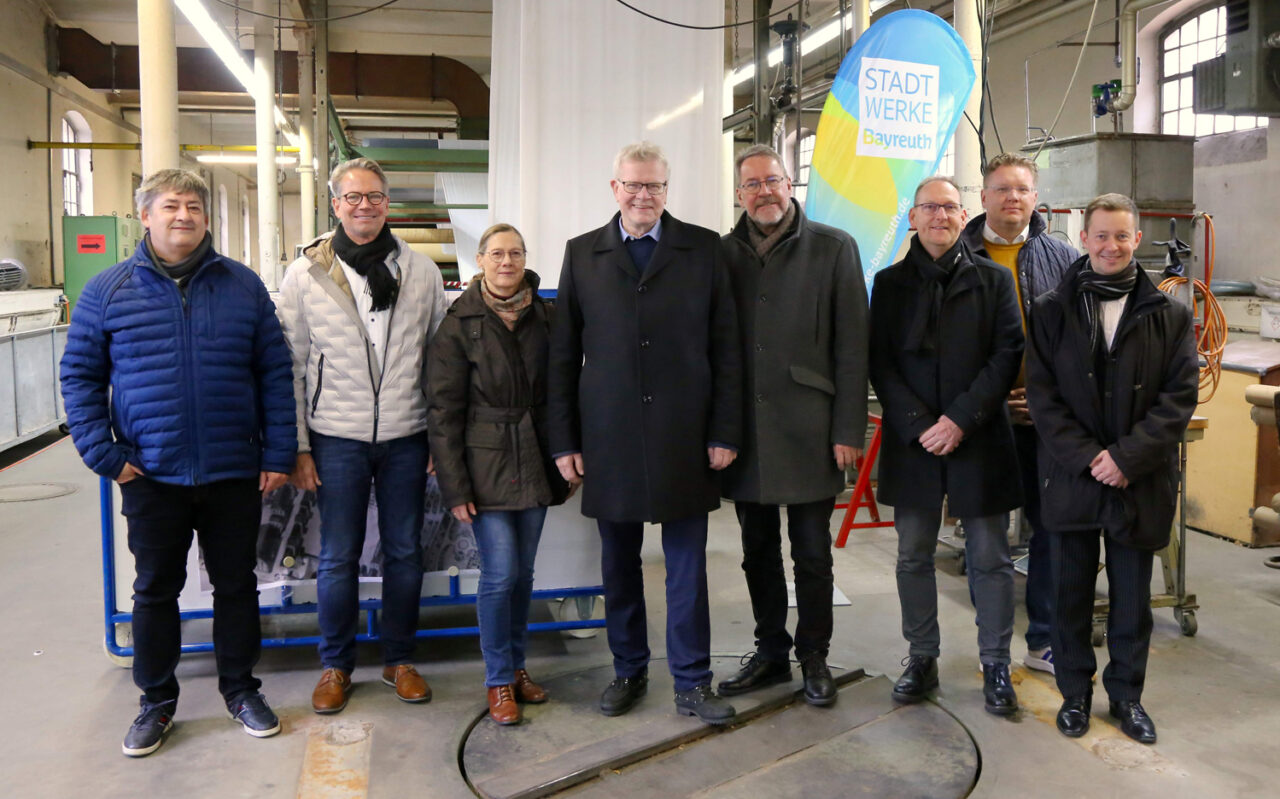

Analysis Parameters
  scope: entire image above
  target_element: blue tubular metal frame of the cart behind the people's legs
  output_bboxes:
[99,478,604,657]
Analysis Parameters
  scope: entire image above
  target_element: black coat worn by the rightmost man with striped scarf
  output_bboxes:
[1027,256,1199,549]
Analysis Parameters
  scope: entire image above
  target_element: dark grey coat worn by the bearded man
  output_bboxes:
[724,205,868,504]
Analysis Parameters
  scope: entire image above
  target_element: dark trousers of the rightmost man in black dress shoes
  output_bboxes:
[1050,533,1155,702]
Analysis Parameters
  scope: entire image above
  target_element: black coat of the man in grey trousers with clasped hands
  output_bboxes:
[870,235,1024,517]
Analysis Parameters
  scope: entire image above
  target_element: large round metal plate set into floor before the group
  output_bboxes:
[461,659,979,799]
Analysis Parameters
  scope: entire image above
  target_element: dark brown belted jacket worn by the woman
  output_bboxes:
[426,270,568,511]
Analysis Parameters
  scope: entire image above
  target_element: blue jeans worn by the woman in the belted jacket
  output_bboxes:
[471,506,547,688]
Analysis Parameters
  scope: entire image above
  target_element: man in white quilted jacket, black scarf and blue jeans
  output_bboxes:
[278,157,448,713]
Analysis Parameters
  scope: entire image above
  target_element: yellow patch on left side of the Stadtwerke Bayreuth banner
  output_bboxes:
[813,95,897,216]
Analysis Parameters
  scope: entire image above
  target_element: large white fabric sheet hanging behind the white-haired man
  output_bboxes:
[488,0,724,288]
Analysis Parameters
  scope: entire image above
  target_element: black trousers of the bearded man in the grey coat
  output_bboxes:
[733,497,836,661]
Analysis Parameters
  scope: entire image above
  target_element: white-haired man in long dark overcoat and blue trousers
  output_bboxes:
[548,142,742,723]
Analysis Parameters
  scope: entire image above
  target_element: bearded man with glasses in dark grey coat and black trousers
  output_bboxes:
[719,145,868,706]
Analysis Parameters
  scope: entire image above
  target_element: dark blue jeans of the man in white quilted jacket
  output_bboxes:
[311,433,428,672]
